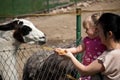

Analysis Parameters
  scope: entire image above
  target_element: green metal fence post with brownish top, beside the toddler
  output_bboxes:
[76,8,82,79]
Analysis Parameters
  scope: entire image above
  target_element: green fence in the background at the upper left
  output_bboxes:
[0,0,80,17]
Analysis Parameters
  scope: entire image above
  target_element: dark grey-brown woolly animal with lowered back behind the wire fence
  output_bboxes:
[22,52,77,80]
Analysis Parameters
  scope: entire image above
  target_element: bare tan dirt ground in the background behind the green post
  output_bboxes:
[23,0,120,45]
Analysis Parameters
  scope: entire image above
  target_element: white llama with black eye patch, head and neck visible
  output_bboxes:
[0,19,46,80]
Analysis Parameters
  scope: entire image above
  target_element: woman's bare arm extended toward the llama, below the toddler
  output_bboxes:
[64,52,104,76]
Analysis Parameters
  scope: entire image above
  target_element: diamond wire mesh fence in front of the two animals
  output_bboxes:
[0,40,76,80]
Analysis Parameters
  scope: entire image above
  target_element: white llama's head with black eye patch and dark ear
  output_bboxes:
[0,19,46,44]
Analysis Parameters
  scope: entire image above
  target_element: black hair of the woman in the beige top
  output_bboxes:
[97,13,120,42]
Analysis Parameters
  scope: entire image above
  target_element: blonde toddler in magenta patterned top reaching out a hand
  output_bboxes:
[56,13,106,80]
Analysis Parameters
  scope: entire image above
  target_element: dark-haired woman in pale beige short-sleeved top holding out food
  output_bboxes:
[56,13,120,80]
